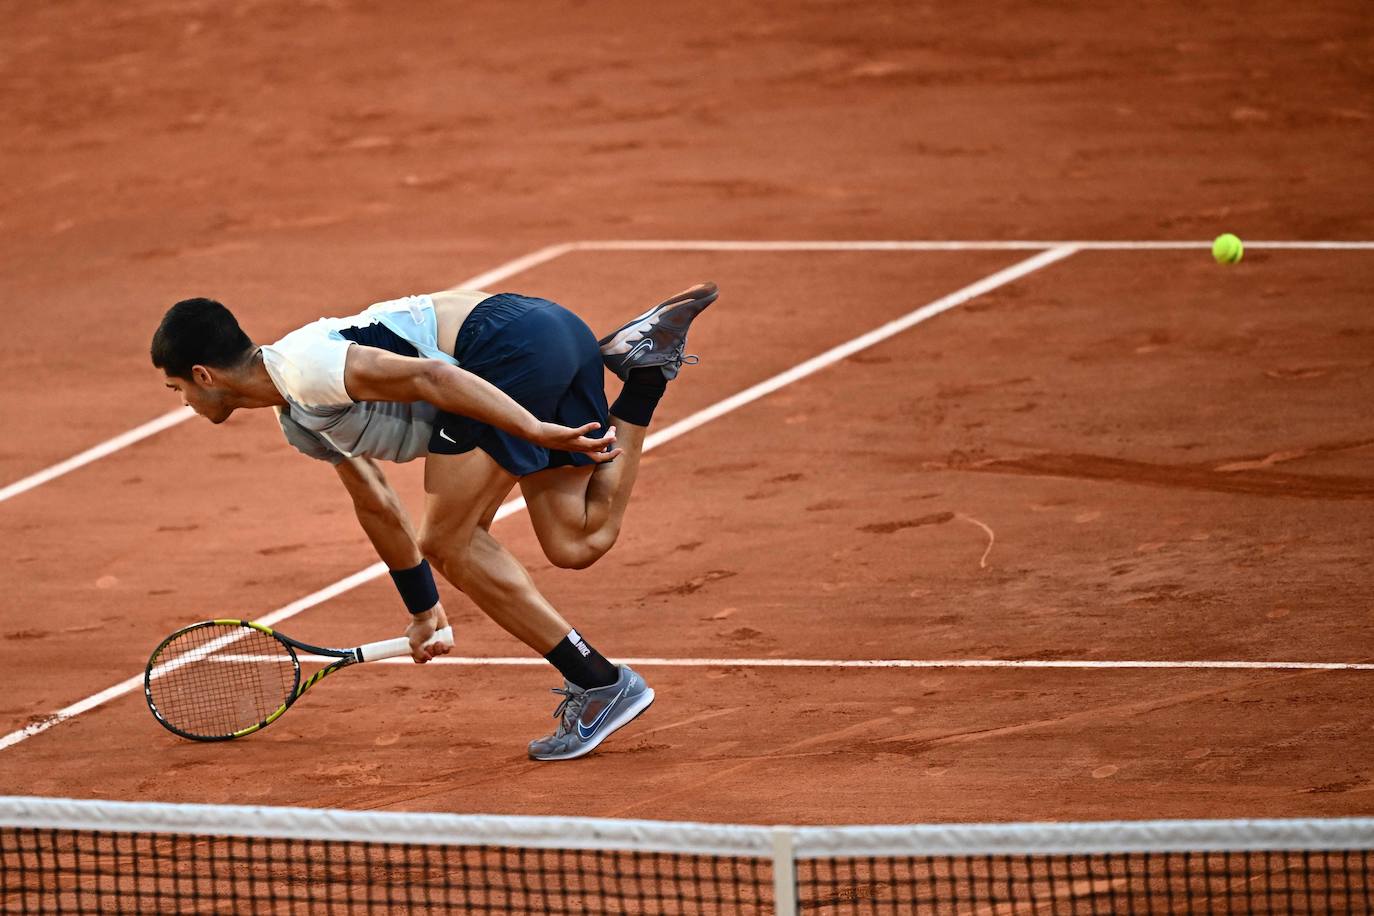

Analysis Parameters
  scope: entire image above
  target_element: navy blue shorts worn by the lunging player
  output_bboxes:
[429,293,610,477]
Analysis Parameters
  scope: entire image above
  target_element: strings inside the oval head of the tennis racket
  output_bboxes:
[148,625,297,737]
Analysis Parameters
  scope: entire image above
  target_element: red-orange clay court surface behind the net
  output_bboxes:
[0,0,1374,911]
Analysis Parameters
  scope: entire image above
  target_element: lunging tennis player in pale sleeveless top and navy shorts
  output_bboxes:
[153,283,717,759]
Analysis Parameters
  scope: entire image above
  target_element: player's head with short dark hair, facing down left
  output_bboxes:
[153,299,256,423]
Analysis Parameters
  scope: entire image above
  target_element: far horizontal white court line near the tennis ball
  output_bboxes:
[569,239,1374,251]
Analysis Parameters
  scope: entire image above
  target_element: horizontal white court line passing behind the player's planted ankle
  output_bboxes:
[267,655,1374,672]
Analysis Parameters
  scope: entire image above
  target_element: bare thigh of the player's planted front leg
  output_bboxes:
[420,449,517,551]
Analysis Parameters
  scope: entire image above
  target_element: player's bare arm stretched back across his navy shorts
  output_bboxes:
[344,346,620,461]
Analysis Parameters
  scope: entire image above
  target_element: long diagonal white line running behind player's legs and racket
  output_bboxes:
[0,247,1074,750]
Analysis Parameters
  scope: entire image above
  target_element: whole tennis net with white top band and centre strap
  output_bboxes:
[0,797,1374,915]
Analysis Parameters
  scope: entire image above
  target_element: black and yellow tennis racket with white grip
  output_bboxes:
[143,621,453,742]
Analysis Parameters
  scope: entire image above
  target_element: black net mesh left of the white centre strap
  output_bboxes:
[0,828,772,915]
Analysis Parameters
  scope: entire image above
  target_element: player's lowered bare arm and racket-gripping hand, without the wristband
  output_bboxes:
[334,457,449,662]
